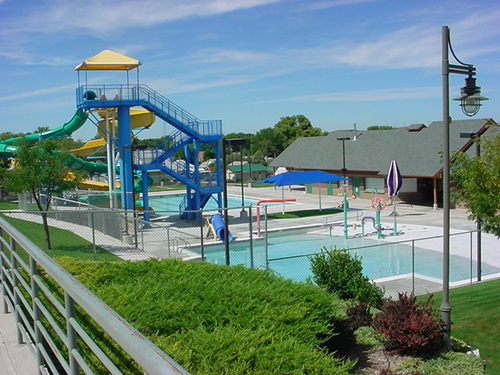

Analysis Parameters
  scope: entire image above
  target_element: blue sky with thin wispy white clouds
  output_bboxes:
[0,0,500,140]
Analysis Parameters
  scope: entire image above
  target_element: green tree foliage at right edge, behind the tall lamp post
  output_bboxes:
[450,126,500,237]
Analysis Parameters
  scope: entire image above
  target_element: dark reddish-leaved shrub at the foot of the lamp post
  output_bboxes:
[373,293,443,355]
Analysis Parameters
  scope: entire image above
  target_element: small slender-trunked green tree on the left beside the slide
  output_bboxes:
[3,139,84,250]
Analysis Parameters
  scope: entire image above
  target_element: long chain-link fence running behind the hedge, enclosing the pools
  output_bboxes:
[3,194,500,295]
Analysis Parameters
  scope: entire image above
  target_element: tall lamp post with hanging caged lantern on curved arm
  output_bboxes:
[440,26,487,348]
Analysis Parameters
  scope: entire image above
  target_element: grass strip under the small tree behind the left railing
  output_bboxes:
[2,215,120,261]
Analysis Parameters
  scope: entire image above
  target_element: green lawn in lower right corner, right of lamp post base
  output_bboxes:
[428,279,500,375]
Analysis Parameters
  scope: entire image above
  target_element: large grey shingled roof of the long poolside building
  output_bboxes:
[270,119,495,177]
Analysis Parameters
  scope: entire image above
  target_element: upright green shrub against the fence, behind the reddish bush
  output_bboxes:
[310,247,384,307]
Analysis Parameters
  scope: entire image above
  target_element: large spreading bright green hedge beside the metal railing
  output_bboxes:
[58,258,353,375]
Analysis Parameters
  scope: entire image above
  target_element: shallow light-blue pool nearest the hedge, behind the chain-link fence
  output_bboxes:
[192,233,500,282]
